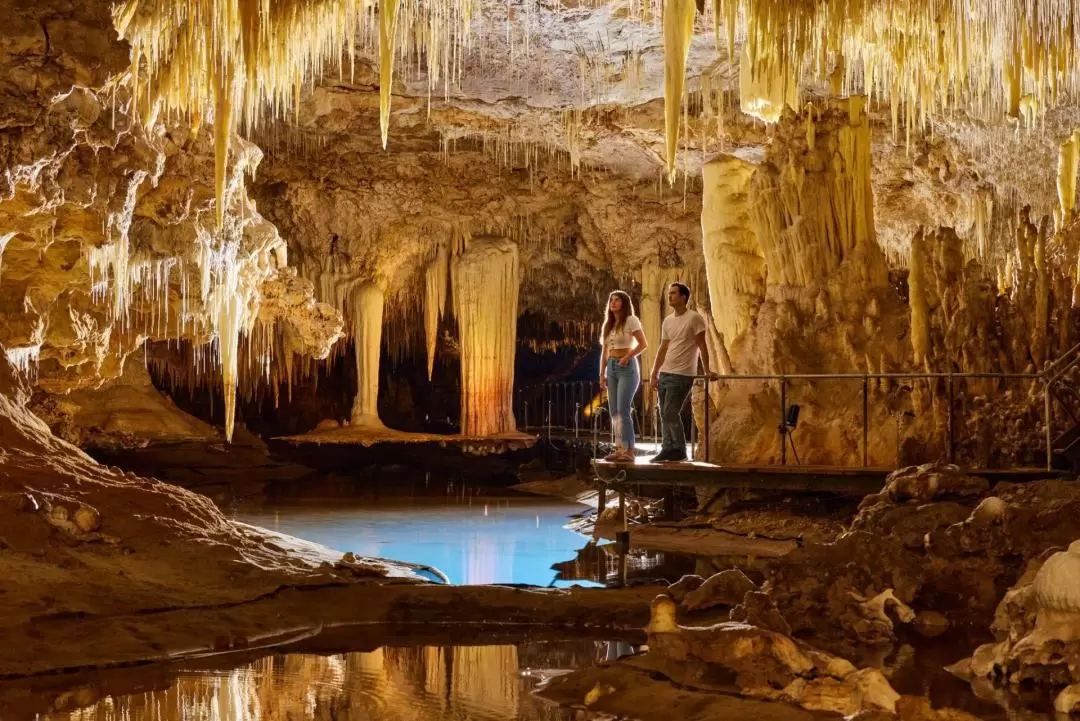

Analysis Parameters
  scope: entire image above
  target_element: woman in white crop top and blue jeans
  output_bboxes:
[600,290,648,463]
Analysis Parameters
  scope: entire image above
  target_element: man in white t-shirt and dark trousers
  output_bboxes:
[649,283,714,463]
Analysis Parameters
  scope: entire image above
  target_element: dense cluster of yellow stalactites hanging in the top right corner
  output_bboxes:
[718,0,1080,130]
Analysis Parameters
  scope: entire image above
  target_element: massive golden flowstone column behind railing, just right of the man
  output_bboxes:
[702,97,906,462]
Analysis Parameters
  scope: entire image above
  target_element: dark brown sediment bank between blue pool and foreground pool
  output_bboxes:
[0,583,661,678]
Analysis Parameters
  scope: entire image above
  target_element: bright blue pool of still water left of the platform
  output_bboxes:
[234,485,596,586]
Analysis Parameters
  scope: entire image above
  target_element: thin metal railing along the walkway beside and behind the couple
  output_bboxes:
[515,343,1080,471]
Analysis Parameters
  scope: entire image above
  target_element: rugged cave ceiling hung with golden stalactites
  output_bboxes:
[0,0,1080,407]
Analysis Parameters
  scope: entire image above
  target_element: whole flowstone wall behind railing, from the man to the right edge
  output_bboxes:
[698,98,1077,465]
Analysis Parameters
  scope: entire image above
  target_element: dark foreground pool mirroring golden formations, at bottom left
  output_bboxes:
[39,641,596,721]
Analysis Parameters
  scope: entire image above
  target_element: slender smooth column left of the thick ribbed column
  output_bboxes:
[348,282,384,427]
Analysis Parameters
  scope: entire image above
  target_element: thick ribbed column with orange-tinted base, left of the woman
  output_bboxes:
[450,237,521,436]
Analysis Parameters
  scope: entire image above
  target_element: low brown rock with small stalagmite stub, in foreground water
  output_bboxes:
[541,595,989,721]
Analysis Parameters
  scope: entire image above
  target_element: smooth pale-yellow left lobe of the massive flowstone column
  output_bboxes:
[701,155,765,346]
